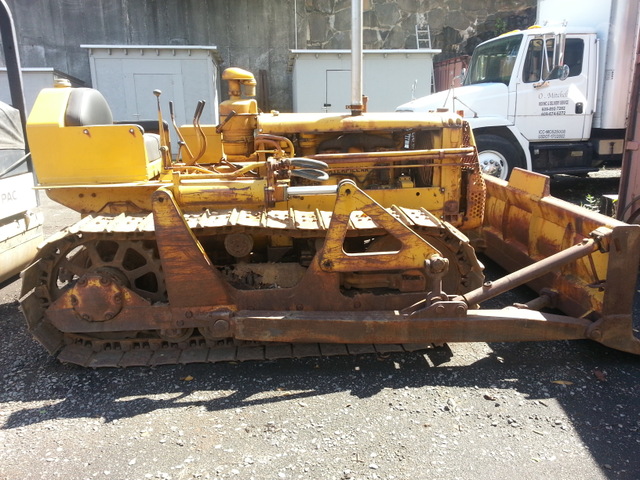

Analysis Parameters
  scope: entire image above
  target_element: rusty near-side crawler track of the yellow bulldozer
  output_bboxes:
[20,207,477,368]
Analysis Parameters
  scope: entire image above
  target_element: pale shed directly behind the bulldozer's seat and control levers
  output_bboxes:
[81,45,221,146]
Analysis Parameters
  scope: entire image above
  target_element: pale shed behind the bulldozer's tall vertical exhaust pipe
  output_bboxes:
[290,48,441,113]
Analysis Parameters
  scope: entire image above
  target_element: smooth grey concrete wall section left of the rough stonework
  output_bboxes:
[7,0,294,110]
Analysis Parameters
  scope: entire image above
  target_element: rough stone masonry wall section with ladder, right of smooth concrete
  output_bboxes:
[298,0,536,59]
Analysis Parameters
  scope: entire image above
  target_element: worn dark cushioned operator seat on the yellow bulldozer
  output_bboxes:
[64,88,162,162]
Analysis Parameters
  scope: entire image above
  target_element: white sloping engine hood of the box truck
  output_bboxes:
[396,83,509,118]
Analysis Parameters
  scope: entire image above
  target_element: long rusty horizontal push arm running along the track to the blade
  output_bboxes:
[235,304,591,344]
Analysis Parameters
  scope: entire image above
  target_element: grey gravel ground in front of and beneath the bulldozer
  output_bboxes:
[0,177,640,480]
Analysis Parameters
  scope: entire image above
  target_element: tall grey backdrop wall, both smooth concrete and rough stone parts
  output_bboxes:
[7,0,536,111]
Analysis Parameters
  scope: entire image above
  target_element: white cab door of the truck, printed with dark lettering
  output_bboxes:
[515,35,595,142]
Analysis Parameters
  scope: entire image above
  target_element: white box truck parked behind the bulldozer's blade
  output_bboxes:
[397,0,640,179]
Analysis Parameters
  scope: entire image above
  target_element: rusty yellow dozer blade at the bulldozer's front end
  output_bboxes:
[481,169,640,354]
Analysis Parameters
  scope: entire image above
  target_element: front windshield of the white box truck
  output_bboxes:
[464,35,522,85]
